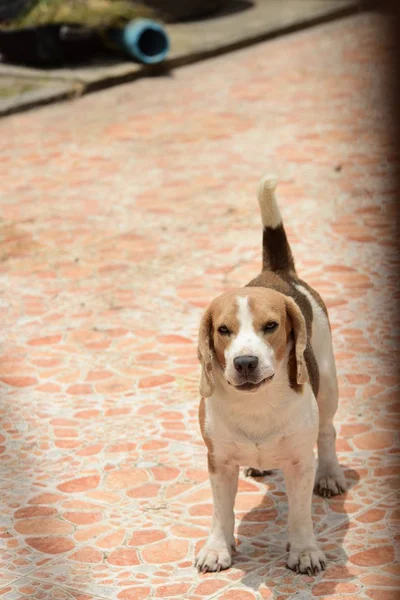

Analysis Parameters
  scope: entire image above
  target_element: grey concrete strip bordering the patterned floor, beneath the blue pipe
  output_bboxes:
[0,0,362,116]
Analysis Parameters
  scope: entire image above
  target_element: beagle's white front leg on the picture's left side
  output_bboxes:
[195,465,239,573]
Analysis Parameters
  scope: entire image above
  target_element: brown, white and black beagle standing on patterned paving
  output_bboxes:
[195,176,346,575]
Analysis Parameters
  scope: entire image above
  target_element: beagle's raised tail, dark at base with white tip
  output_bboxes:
[258,175,296,273]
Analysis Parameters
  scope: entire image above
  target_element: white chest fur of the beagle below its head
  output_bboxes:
[205,381,318,470]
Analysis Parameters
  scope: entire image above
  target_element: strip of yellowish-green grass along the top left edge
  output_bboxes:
[1,0,159,29]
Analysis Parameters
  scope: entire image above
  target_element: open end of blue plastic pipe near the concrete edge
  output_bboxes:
[110,19,169,65]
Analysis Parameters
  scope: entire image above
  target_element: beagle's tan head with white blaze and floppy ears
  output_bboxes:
[198,287,308,398]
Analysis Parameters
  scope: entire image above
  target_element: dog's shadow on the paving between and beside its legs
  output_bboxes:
[233,465,359,598]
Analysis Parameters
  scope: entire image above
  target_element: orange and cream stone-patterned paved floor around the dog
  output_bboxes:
[0,15,400,600]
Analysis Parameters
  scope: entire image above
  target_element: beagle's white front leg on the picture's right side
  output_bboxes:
[284,452,326,575]
